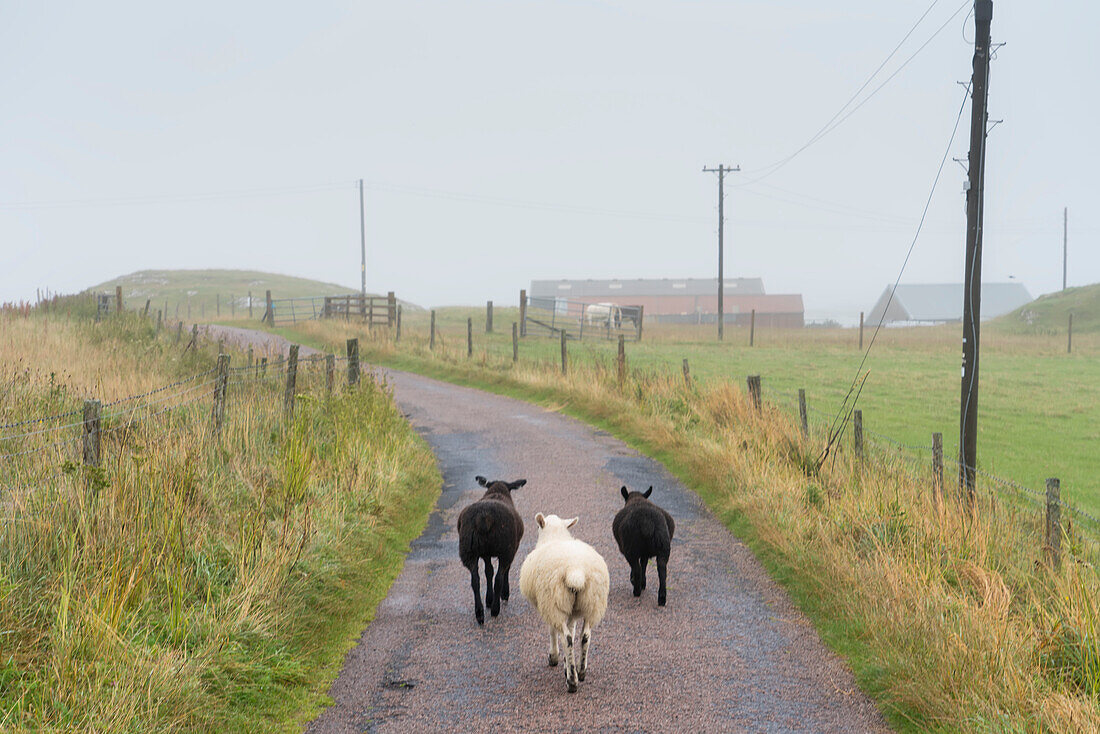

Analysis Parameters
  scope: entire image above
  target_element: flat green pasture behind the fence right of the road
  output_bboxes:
[403,303,1100,514]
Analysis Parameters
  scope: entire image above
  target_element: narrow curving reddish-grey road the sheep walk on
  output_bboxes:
[198,327,889,733]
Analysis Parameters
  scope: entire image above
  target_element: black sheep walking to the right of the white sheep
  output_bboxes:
[612,486,677,606]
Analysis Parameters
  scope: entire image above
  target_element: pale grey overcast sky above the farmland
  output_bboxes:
[0,0,1100,317]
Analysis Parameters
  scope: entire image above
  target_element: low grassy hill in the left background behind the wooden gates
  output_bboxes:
[88,270,374,318]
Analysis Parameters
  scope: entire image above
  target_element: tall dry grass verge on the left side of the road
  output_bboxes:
[0,301,439,732]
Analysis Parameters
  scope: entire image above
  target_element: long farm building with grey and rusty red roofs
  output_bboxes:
[529,277,805,327]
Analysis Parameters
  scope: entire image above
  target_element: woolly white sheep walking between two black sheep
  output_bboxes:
[519,513,611,693]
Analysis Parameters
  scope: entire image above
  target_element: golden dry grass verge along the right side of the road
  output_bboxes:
[286,322,1100,732]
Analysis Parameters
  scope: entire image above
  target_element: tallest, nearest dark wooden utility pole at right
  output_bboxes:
[959,0,993,512]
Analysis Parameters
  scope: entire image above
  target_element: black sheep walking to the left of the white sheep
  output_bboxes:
[459,476,527,624]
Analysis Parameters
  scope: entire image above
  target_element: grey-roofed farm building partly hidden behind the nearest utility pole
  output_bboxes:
[867,283,1032,324]
